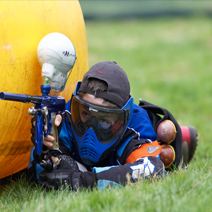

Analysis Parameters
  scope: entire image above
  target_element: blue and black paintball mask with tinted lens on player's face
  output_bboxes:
[71,83,133,166]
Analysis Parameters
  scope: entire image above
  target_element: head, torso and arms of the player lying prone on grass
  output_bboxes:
[28,61,198,190]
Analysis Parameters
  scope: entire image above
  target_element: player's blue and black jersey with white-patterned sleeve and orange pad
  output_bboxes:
[30,97,165,188]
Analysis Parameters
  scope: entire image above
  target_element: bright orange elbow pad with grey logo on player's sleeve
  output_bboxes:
[126,141,161,163]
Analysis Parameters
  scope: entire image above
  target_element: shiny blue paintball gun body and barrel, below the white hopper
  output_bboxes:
[0,85,65,162]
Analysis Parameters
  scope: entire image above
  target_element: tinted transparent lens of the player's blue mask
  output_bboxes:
[71,96,129,142]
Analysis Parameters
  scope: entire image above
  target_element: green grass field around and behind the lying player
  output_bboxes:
[0,17,212,212]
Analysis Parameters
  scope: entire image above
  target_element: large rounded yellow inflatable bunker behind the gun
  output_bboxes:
[0,1,88,179]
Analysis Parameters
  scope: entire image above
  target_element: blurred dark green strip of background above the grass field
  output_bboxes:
[79,0,212,20]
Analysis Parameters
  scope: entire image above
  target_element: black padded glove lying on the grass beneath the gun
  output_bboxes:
[39,156,97,191]
